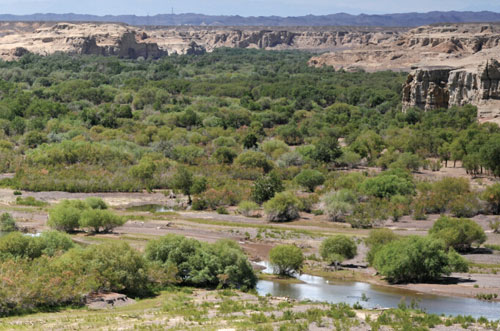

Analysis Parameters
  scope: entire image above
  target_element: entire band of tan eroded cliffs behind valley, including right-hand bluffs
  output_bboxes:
[0,22,500,123]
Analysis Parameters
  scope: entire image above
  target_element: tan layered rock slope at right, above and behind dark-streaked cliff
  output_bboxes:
[310,24,500,71]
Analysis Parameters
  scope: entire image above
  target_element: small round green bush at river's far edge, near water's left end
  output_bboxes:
[269,245,304,276]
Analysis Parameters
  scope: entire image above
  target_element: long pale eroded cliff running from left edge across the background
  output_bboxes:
[0,22,404,60]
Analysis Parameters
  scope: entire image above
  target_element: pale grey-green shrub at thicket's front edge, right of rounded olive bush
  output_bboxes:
[322,189,358,222]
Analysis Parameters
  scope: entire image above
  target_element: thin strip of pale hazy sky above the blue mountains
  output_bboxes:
[0,0,500,16]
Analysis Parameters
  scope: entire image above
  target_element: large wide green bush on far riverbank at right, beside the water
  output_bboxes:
[373,236,467,283]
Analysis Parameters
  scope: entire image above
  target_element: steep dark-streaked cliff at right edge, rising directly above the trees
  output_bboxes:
[403,59,500,121]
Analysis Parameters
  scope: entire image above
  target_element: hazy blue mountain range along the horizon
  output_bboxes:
[0,11,500,27]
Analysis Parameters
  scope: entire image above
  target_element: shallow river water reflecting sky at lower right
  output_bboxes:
[257,263,500,320]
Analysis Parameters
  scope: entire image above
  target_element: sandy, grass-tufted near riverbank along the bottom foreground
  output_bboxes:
[0,287,498,331]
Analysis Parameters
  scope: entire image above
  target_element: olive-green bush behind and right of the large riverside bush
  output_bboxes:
[429,216,486,252]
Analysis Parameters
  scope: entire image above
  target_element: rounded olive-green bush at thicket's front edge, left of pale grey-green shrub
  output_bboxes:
[264,192,300,222]
